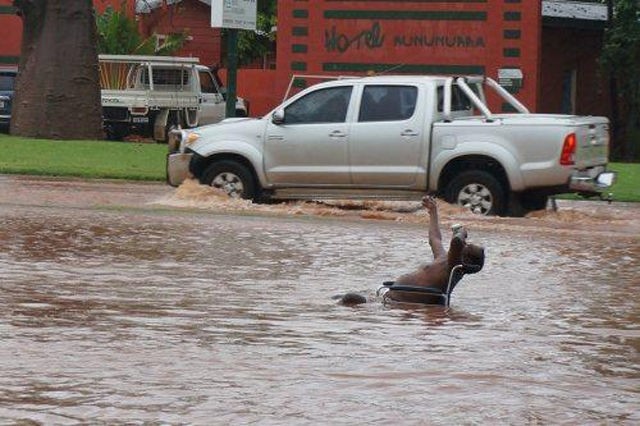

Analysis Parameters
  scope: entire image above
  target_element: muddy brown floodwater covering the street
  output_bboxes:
[0,176,640,425]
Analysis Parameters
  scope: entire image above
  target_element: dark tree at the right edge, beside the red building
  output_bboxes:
[600,0,640,161]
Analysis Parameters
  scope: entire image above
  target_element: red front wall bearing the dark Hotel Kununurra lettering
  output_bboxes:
[277,0,541,110]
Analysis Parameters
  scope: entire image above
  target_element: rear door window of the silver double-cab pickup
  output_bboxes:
[358,85,418,122]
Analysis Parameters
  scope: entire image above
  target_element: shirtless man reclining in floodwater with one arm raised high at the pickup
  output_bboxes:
[388,197,484,302]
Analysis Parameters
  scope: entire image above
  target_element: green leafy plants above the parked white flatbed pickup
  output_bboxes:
[96,2,187,55]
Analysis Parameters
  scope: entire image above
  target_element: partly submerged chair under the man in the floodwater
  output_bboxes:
[378,265,469,306]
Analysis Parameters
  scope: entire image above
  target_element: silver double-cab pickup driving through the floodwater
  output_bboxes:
[167,75,615,216]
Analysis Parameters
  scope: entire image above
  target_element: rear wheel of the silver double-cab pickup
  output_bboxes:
[445,170,506,215]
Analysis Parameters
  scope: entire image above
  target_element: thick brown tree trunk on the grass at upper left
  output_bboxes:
[11,0,102,139]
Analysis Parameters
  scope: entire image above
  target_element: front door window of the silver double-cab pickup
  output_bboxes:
[285,86,352,124]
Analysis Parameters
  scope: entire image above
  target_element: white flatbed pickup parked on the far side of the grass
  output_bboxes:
[99,55,248,142]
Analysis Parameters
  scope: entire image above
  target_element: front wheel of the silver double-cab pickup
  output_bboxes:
[200,160,256,200]
